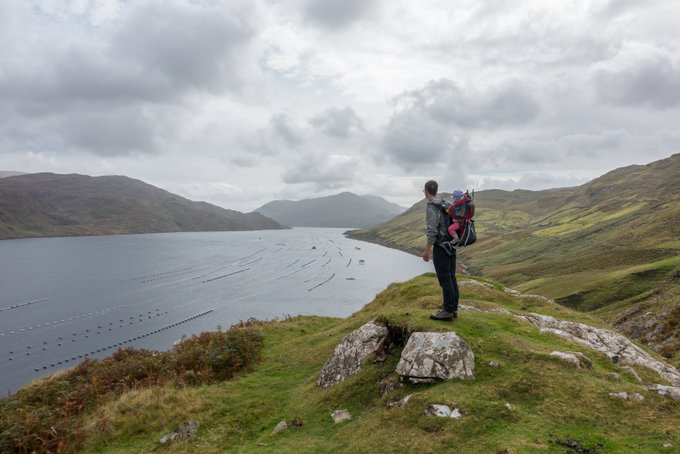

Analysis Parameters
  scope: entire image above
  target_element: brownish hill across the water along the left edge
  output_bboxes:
[0,173,285,239]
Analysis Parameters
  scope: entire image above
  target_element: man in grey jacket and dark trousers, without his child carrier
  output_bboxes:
[423,180,458,321]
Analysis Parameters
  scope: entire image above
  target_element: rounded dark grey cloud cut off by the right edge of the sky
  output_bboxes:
[592,44,680,109]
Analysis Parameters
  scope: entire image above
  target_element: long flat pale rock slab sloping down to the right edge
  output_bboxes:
[516,314,680,385]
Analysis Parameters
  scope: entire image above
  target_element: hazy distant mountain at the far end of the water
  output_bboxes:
[255,192,406,227]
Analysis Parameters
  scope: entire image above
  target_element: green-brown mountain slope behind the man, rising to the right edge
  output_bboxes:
[350,154,680,310]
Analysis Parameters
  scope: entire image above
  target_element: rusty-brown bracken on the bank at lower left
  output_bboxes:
[0,327,262,452]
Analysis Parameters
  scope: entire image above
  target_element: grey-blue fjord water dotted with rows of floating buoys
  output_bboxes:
[0,228,432,394]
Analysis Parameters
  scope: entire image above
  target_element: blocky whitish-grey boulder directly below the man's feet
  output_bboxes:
[397,331,475,383]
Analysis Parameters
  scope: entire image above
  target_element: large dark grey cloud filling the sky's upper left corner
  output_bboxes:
[0,3,254,105]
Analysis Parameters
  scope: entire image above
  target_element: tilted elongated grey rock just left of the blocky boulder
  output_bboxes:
[316,322,387,388]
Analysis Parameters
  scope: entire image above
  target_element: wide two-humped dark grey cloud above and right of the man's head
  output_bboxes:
[400,79,539,128]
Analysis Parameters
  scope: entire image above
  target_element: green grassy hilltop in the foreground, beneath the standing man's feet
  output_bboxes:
[0,274,680,453]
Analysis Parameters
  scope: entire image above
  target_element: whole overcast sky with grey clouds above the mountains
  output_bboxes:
[0,0,680,211]
